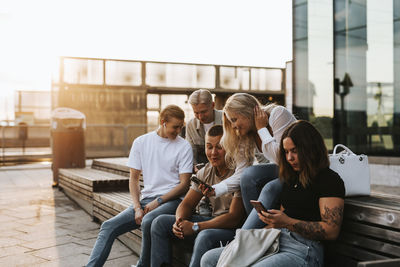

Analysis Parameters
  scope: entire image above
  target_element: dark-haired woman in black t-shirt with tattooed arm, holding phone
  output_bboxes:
[201,121,345,267]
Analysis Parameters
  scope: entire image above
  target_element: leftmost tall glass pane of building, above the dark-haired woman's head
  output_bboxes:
[293,0,333,149]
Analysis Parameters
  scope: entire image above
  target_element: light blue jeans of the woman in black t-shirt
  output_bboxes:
[201,228,324,267]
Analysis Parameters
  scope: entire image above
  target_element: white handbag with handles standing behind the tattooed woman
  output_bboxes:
[329,144,371,197]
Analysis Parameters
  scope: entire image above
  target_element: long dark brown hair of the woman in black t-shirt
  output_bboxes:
[279,120,329,187]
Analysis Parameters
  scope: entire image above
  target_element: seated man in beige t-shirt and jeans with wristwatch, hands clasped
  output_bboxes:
[151,125,245,267]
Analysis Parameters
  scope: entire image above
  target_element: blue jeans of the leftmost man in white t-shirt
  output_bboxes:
[86,197,181,267]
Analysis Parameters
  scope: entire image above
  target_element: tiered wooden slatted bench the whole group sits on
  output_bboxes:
[60,158,400,267]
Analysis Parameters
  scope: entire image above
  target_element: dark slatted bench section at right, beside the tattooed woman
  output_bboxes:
[325,195,400,267]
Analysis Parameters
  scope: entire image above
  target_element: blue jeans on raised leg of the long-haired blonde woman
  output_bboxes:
[240,163,280,215]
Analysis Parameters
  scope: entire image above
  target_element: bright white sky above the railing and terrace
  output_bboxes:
[0,0,292,120]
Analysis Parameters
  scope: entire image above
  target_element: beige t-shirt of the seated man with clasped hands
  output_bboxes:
[190,163,238,217]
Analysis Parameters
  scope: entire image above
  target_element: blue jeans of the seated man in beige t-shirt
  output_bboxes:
[151,215,235,267]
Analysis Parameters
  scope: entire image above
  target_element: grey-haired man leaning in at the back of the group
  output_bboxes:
[186,89,222,168]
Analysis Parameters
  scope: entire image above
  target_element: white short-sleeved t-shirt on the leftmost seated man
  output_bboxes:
[127,131,193,199]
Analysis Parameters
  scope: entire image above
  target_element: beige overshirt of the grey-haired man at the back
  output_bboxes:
[186,109,223,164]
